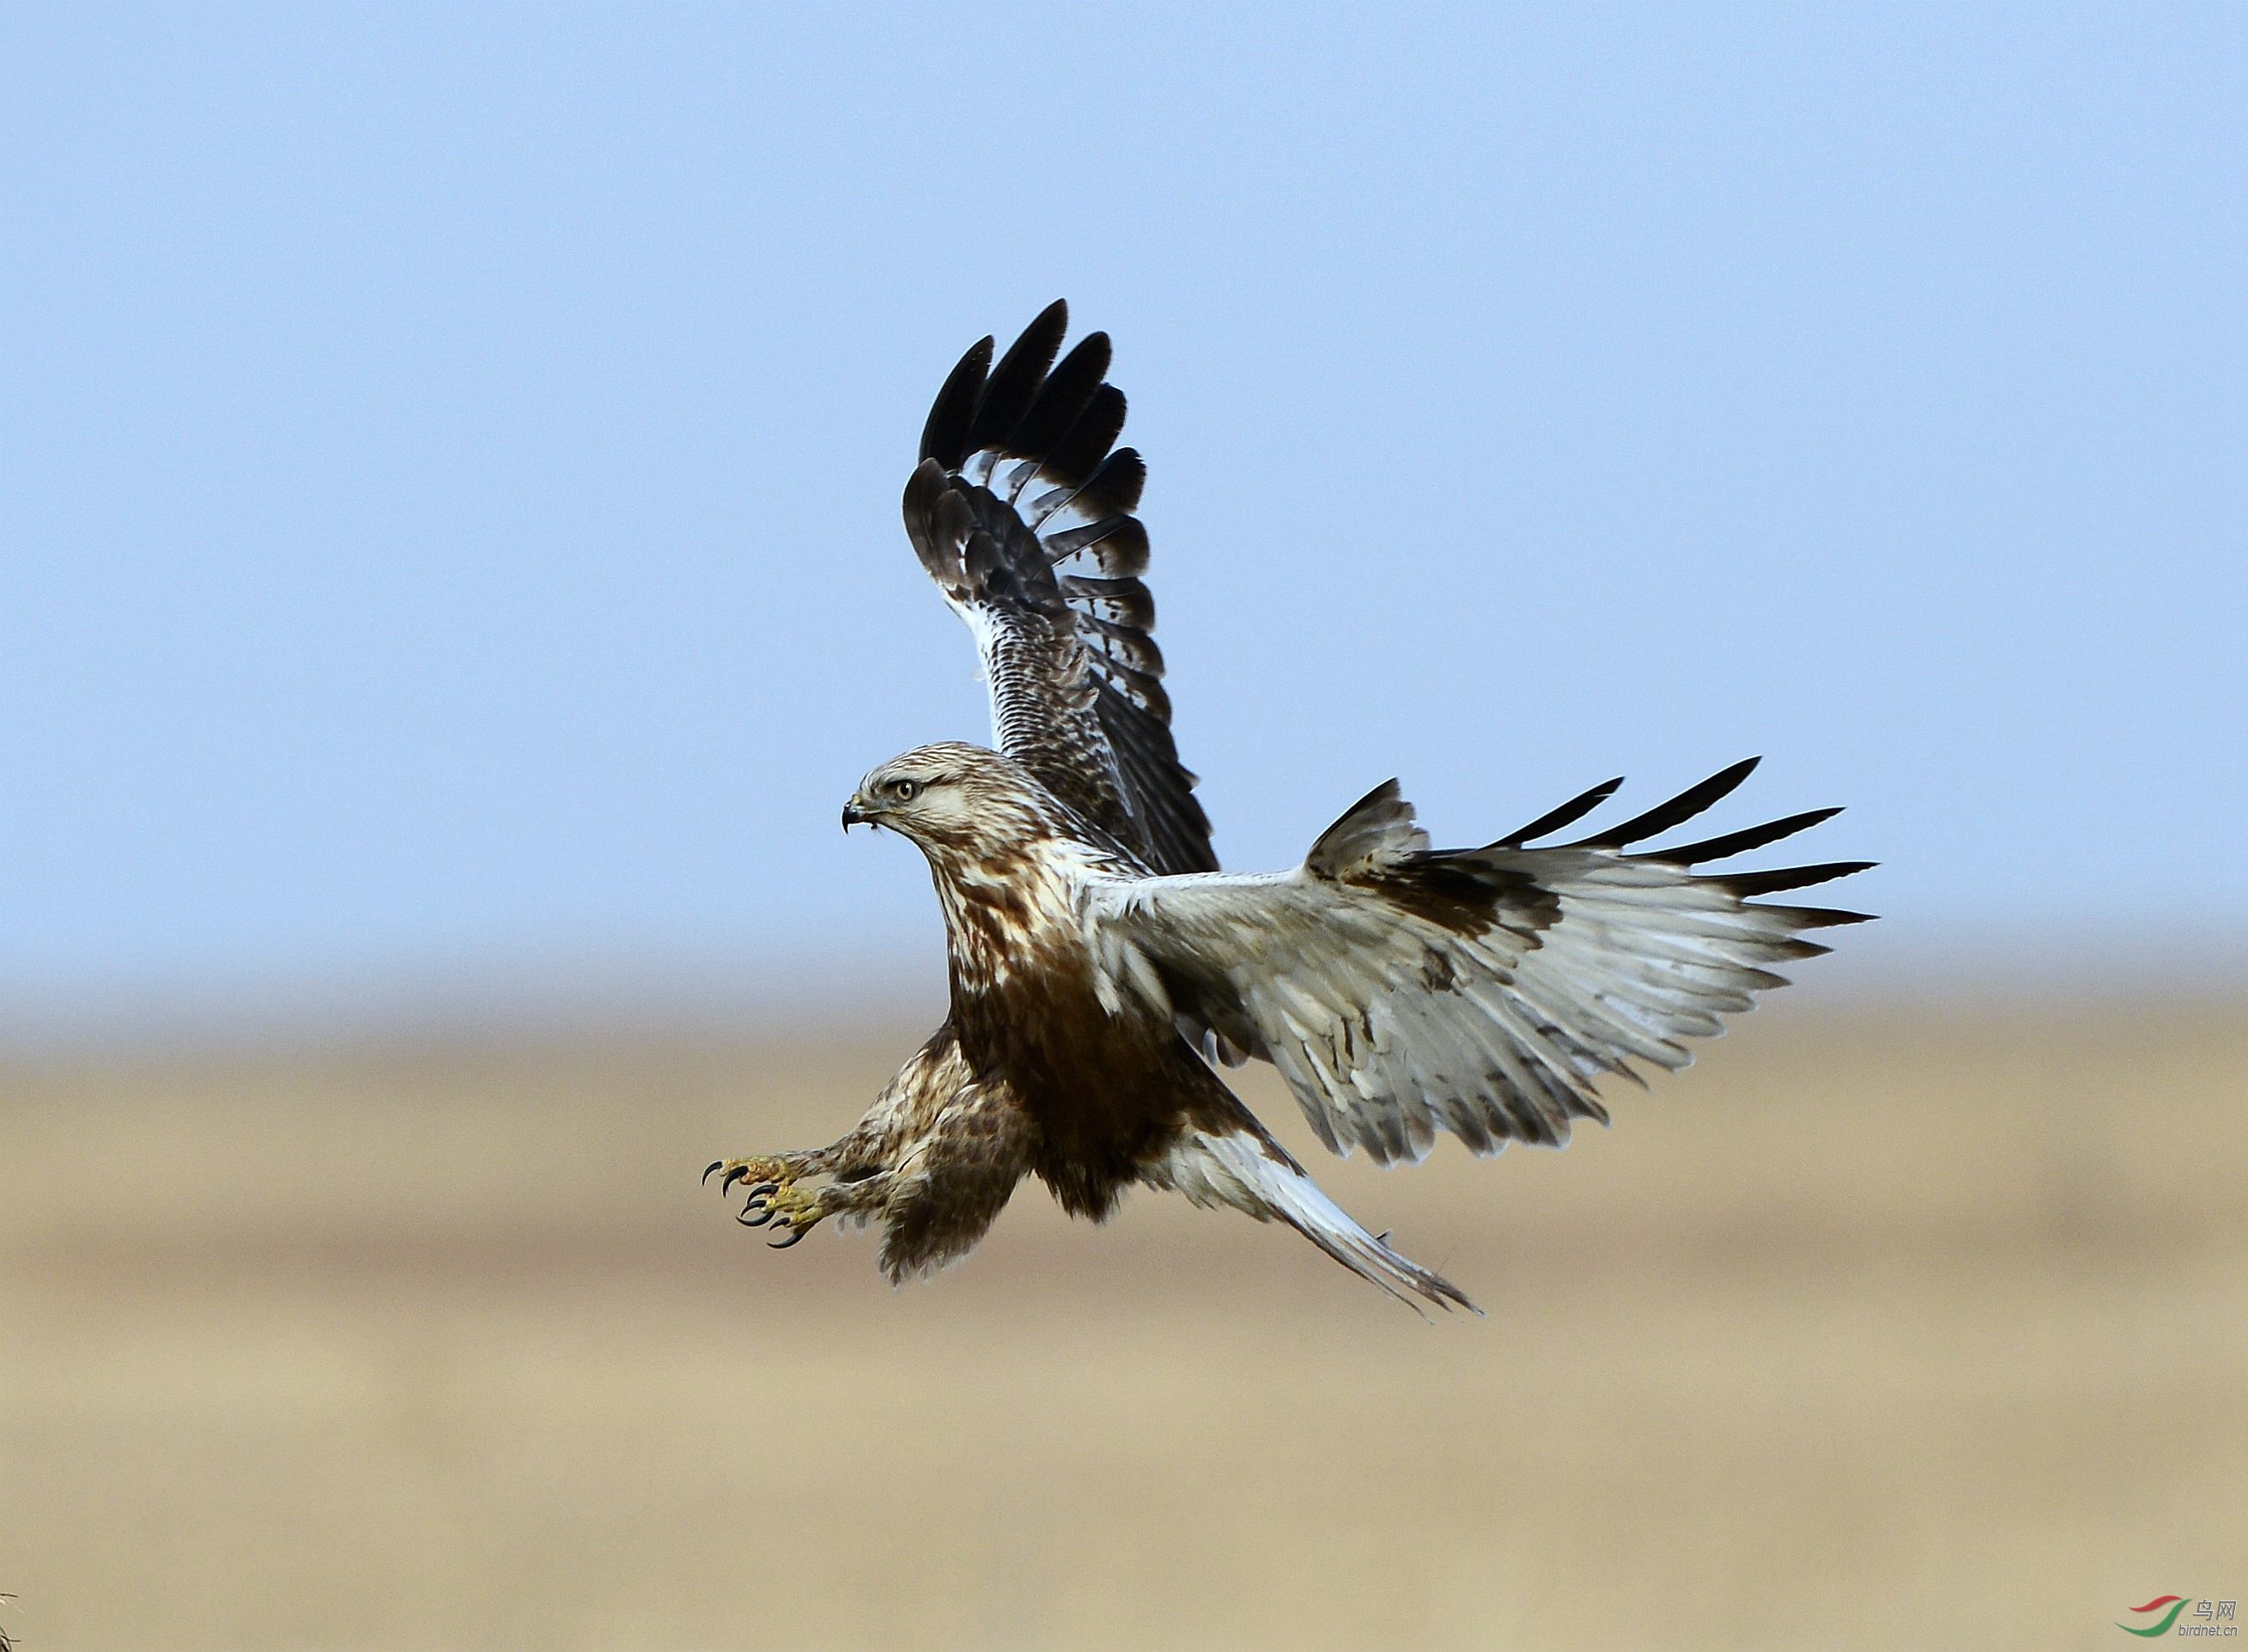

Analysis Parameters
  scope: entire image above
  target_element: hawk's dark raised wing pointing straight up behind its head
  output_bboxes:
[906,301,1218,872]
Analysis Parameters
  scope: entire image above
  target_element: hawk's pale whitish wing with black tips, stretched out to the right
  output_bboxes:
[1088,757,1870,1162]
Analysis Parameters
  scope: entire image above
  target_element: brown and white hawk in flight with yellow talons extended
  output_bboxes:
[703,303,1868,1308]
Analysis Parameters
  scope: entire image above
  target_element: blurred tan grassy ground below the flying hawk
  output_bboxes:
[0,1000,2248,1652]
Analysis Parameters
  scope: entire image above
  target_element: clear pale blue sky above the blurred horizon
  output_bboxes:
[0,4,2248,1009]
